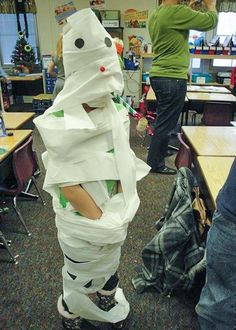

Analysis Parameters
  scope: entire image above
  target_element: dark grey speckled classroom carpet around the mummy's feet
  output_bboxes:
[0,113,201,330]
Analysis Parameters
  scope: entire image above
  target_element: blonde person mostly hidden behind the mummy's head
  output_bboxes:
[48,34,65,99]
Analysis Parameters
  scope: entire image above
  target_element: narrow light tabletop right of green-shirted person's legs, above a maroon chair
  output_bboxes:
[187,92,236,102]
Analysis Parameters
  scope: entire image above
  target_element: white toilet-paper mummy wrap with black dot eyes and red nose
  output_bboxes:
[34,9,150,323]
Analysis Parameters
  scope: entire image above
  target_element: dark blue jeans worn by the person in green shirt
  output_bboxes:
[147,77,187,171]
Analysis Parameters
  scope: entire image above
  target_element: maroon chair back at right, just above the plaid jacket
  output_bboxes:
[175,133,192,169]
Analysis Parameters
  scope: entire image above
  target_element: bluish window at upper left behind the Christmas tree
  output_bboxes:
[0,14,38,65]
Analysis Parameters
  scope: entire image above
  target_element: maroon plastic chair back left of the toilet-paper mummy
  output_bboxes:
[12,136,35,191]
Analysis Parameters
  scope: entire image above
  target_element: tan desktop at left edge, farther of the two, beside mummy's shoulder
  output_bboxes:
[2,112,35,130]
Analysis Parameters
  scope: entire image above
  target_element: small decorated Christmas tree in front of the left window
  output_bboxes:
[11,32,36,71]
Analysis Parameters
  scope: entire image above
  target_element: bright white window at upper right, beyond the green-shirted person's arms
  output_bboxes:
[213,12,236,68]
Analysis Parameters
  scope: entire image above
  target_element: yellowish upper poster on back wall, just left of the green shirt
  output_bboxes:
[124,9,148,28]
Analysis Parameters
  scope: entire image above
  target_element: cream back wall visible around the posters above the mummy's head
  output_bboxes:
[36,0,157,54]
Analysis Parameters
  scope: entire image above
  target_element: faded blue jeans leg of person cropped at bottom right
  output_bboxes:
[196,211,236,330]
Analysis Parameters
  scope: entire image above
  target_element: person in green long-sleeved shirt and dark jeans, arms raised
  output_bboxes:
[147,0,218,174]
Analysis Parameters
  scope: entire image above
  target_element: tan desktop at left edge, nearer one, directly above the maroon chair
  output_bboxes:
[0,129,32,163]
